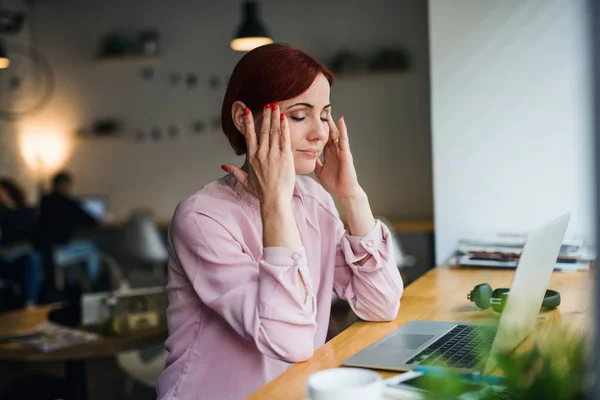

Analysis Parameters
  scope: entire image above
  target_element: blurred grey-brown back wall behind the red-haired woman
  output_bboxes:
[0,0,433,219]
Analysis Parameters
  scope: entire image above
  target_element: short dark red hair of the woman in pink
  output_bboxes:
[221,43,334,155]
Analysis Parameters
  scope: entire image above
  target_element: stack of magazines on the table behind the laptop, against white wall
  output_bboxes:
[447,234,594,271]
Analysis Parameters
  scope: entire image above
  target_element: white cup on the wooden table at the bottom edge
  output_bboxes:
[306,368,383,400]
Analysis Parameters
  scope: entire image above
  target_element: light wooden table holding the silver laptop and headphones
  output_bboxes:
[249,267,593,400]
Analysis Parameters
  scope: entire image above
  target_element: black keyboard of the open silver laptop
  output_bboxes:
[407,325,497,368]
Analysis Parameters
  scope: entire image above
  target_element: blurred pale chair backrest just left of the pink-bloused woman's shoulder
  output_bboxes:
[124,212,168,263]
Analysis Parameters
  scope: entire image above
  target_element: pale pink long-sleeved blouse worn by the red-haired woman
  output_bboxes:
[157,175,403,400]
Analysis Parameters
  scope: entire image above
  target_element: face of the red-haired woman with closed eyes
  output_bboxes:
[277,74,331,175]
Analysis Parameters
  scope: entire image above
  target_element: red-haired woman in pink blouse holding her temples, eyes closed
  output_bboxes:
[157,44,403,400]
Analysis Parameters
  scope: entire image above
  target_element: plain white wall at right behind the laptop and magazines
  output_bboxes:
[429,0,594,263]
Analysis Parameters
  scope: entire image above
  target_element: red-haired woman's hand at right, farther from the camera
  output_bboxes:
[315,115,364,200]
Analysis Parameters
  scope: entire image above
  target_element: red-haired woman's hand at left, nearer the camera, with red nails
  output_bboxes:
[223,103,296,207]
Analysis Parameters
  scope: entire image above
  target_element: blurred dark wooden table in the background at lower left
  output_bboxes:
[0,303,167,400]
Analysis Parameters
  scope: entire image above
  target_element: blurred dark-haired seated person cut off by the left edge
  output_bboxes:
[0,178,44,307]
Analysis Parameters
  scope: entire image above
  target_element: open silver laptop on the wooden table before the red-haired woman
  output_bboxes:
[342,213,571,372]
